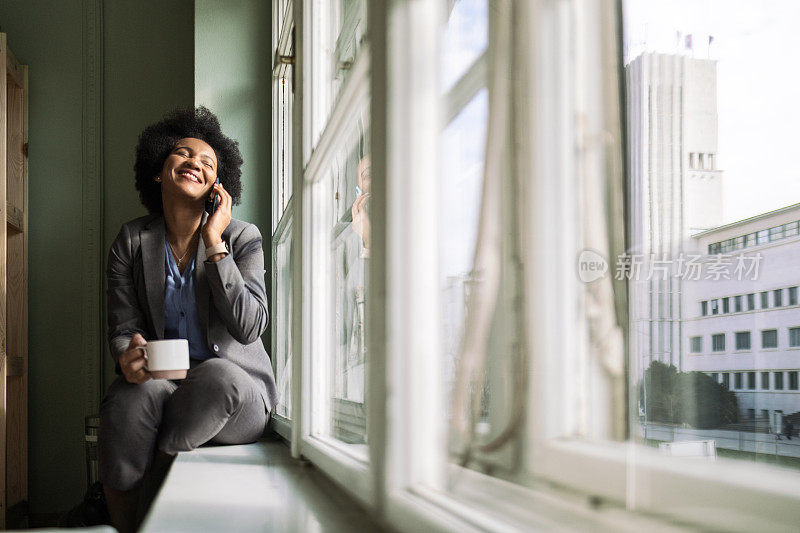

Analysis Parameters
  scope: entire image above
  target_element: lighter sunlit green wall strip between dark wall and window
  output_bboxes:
[194,0,272,351]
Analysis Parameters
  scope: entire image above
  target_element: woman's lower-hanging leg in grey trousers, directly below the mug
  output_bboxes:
[97,377,177,533]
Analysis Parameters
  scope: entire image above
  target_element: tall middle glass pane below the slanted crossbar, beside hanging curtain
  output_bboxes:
[438,89,517,476]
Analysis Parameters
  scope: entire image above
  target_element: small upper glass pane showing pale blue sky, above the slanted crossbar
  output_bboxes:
[440,0,489,92]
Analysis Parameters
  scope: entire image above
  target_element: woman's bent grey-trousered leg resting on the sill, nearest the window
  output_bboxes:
[158,358,267,455]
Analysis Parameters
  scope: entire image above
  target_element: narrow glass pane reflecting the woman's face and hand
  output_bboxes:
[310,112,371,458]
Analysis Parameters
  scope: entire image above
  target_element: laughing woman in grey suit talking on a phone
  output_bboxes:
[98,107,277,532]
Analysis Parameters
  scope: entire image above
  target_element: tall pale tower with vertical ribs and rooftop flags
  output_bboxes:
[626,53,722,373]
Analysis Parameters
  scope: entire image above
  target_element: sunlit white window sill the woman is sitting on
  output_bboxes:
[141,441,384,532]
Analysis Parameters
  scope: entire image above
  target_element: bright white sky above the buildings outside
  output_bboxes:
[623,0,800,223]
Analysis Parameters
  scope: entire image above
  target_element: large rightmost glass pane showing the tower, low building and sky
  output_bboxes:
[622,0,800,469]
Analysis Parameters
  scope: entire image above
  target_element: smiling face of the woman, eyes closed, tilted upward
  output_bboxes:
[157,137,217,200]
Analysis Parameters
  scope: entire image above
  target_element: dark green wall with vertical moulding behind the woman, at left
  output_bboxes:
[0,0,194,523]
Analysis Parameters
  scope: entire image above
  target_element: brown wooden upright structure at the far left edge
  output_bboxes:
[0,33,28,527]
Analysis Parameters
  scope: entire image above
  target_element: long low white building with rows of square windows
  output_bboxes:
[682,204,800,418]
